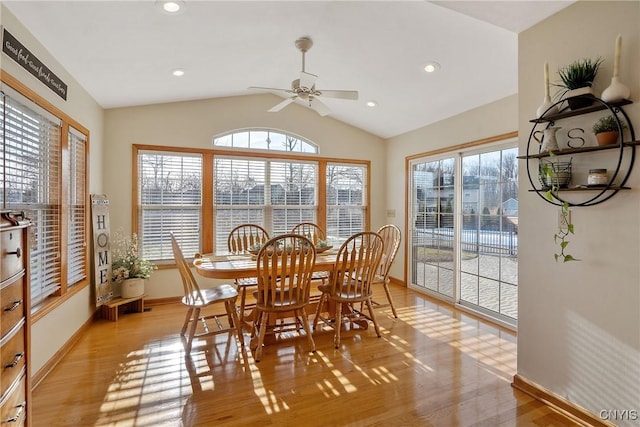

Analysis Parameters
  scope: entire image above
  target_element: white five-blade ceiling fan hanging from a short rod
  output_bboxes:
[249,37,358,116]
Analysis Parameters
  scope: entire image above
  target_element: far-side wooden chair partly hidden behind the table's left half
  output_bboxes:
[227,224,269,324]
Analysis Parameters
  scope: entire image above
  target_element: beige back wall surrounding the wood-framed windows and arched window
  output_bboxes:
[103,95,386,299]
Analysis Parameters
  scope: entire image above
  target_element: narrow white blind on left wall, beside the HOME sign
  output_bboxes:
[67,129,87,286]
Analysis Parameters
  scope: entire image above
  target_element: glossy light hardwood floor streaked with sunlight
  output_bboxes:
[33,286,575,427]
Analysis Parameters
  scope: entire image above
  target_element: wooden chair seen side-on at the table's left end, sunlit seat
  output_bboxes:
[171,233,247,361]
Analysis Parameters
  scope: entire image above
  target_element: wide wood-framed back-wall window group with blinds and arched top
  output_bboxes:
[134,130,370,263]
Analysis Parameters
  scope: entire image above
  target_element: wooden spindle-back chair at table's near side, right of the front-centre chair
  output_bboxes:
[313,231,384,348]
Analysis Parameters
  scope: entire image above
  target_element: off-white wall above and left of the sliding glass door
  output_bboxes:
[385,96,518,280]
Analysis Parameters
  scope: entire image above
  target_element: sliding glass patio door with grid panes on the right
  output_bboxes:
[408,144,518,324]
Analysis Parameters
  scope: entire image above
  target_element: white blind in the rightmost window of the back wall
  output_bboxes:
[327,163,367,244]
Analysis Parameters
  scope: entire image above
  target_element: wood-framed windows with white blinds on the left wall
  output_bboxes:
[0,77,89,310]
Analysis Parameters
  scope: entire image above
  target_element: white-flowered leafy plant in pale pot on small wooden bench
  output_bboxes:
[111,233,157,298]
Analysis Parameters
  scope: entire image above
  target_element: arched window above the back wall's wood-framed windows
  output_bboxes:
[213,129,318,153]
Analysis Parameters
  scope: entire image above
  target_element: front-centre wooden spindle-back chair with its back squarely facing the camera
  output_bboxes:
[253,233,316,362]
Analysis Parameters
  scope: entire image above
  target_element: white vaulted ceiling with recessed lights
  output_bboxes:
[3,0,572,138]
